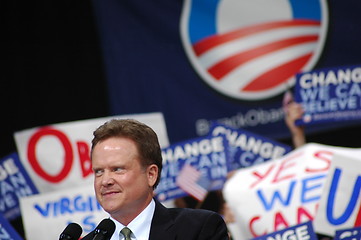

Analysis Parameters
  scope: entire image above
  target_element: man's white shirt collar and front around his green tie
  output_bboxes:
[110,199,155,240]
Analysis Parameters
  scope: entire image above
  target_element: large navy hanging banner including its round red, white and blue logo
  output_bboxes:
[93,0,361,143]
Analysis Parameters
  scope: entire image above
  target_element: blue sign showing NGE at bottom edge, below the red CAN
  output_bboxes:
[253,221,317,240]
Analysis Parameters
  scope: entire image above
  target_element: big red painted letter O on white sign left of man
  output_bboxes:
[27,127,74,183]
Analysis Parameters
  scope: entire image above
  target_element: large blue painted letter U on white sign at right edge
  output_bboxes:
[326,168,361,225]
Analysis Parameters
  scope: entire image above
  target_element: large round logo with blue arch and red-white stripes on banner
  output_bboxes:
[180,0,328,100]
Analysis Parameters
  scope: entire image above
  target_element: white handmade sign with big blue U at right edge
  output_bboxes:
[314,154,361,236]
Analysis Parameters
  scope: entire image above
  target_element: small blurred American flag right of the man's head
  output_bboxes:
[177,164,210,201]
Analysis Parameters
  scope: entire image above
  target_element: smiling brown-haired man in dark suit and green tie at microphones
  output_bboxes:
[83,119,229,240]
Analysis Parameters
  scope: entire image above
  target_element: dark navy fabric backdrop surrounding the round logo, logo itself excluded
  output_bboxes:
[94,0,361,142]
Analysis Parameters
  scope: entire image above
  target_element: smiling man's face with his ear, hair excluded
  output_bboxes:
[92,137,158,218]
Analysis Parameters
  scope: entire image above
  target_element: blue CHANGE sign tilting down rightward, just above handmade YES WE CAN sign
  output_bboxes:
[210,122,292,170]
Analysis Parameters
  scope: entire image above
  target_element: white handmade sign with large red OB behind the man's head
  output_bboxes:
[15,113,169,192]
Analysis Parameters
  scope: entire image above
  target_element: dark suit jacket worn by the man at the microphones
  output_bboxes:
[82,200,229,240]
